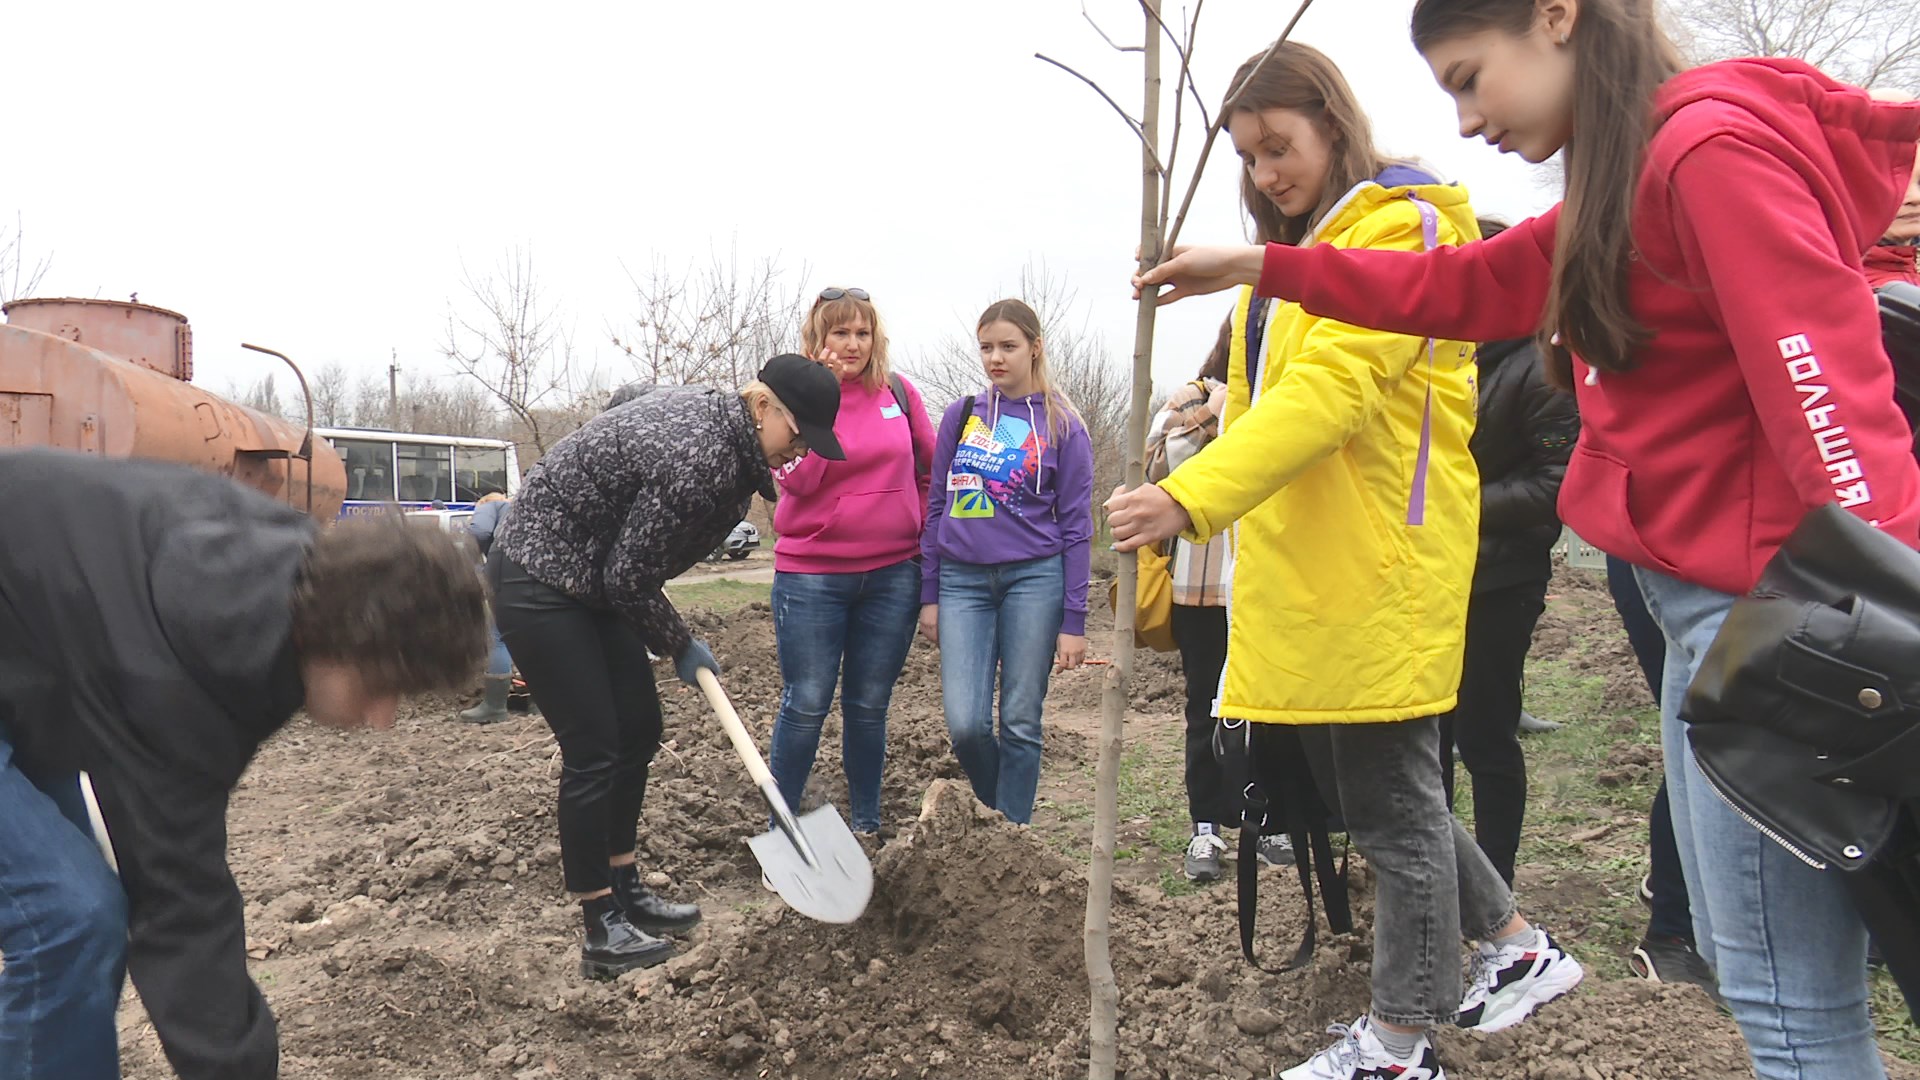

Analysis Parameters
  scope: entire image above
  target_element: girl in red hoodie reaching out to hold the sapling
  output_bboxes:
[1110,0,1920,1080]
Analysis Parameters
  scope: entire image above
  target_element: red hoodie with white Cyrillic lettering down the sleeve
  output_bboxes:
[1260,60,1920,594]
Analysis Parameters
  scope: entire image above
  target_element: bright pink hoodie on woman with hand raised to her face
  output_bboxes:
[774,377,933,575]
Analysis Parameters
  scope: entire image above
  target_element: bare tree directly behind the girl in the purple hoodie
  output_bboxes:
[913,263,1133,502]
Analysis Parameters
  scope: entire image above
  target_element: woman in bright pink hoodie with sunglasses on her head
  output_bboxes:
[770,288,933,834]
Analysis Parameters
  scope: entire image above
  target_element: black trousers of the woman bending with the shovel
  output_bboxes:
[488,548,660,894]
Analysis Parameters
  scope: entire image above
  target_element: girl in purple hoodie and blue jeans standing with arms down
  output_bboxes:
[920,300,1092,824]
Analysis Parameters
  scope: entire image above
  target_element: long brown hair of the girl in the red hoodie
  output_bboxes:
[1413,0,1686,388]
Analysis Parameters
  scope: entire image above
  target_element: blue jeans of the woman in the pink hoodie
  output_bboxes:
[768,559,920,832]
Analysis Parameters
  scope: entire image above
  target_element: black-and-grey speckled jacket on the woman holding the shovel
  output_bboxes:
[493,386,776,657]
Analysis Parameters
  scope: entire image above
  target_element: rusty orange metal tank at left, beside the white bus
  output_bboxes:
[0,300,346,521]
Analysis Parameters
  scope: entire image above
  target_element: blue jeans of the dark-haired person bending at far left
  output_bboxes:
[0,728,127,1080]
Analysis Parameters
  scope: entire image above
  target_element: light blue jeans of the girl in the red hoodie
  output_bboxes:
[1636,569,1885,1080]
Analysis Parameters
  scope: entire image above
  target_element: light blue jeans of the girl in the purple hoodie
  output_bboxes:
[941,555,1066,824]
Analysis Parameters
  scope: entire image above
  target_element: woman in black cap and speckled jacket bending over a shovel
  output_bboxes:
[488,356,841,978]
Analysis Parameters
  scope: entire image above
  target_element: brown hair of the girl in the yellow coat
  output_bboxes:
[1221,40,1388,244]
